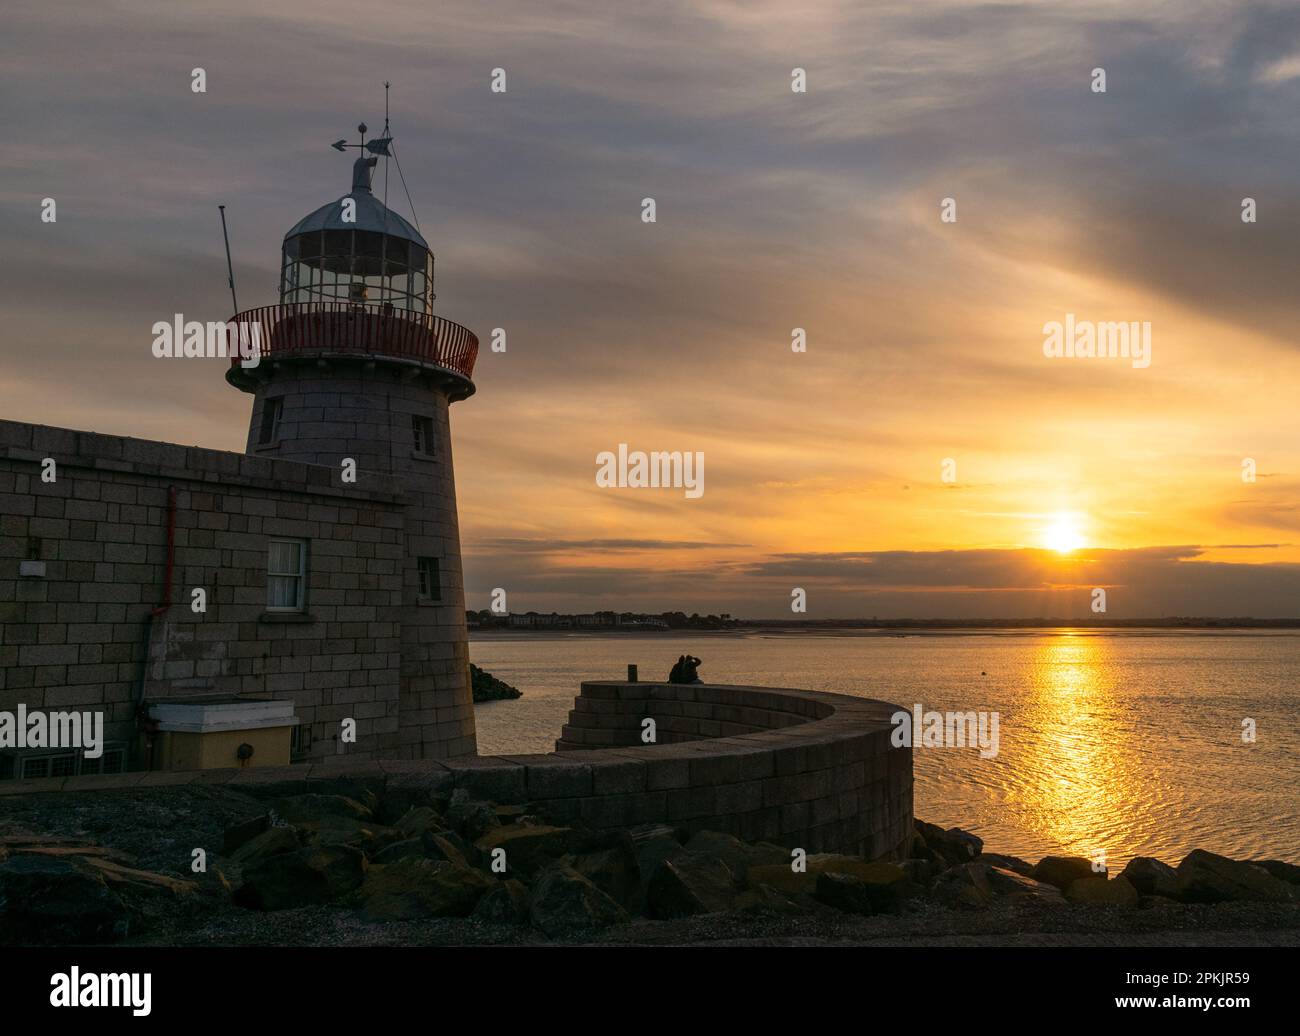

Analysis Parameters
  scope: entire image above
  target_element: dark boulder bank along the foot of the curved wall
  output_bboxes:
[0,780,1300,945]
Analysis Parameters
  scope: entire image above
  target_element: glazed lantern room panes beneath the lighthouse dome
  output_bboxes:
[280,230,433,317]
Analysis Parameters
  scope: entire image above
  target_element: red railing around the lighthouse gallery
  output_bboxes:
[228,302,478,378]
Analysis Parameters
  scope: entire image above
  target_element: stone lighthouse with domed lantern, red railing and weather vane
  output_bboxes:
[226,125,478,759]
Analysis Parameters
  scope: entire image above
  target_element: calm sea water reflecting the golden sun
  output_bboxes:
[469,632,1300,868]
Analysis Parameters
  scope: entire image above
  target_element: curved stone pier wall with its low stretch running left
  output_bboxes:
[0,681,913,859]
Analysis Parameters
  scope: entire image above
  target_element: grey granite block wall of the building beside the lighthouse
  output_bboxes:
[0,421,407,762]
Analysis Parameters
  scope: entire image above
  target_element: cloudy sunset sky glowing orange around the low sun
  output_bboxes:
[0,0,1300,619]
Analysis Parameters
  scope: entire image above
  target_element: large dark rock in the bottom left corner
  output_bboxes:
[0,853,130,946]
